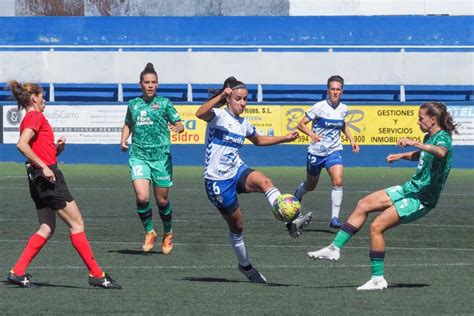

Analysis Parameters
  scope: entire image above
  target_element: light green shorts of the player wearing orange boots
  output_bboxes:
[128,157,173,188]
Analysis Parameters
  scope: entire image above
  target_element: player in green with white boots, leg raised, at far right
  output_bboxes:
[308,102,457,290]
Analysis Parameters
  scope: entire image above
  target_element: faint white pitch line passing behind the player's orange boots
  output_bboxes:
[0,239,474,252]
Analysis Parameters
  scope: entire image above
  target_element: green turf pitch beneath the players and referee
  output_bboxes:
[0,163,474,315]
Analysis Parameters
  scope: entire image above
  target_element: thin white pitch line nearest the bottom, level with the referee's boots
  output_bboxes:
[9,262,474,270]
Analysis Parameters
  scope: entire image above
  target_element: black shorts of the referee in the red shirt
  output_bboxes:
[26,163,74,210]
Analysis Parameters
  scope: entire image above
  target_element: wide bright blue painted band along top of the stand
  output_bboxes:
[0,16,474,46]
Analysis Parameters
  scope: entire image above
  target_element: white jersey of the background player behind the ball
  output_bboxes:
[306,100,348,156]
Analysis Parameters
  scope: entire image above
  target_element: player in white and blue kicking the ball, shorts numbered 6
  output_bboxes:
[196,77,312,283]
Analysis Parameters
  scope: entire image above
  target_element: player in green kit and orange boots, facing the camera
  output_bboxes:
[120,63,184,254]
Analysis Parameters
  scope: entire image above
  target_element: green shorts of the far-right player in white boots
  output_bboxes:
[385,185,432,224]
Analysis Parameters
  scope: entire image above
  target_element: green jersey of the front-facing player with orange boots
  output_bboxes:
[125,96,181,161]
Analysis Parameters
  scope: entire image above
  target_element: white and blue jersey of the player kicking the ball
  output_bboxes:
[204,109,255,180]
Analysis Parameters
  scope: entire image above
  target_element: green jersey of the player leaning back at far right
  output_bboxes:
[403,130,453,208]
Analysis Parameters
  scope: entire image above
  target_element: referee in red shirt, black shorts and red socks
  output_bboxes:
[7,81,121,289]
